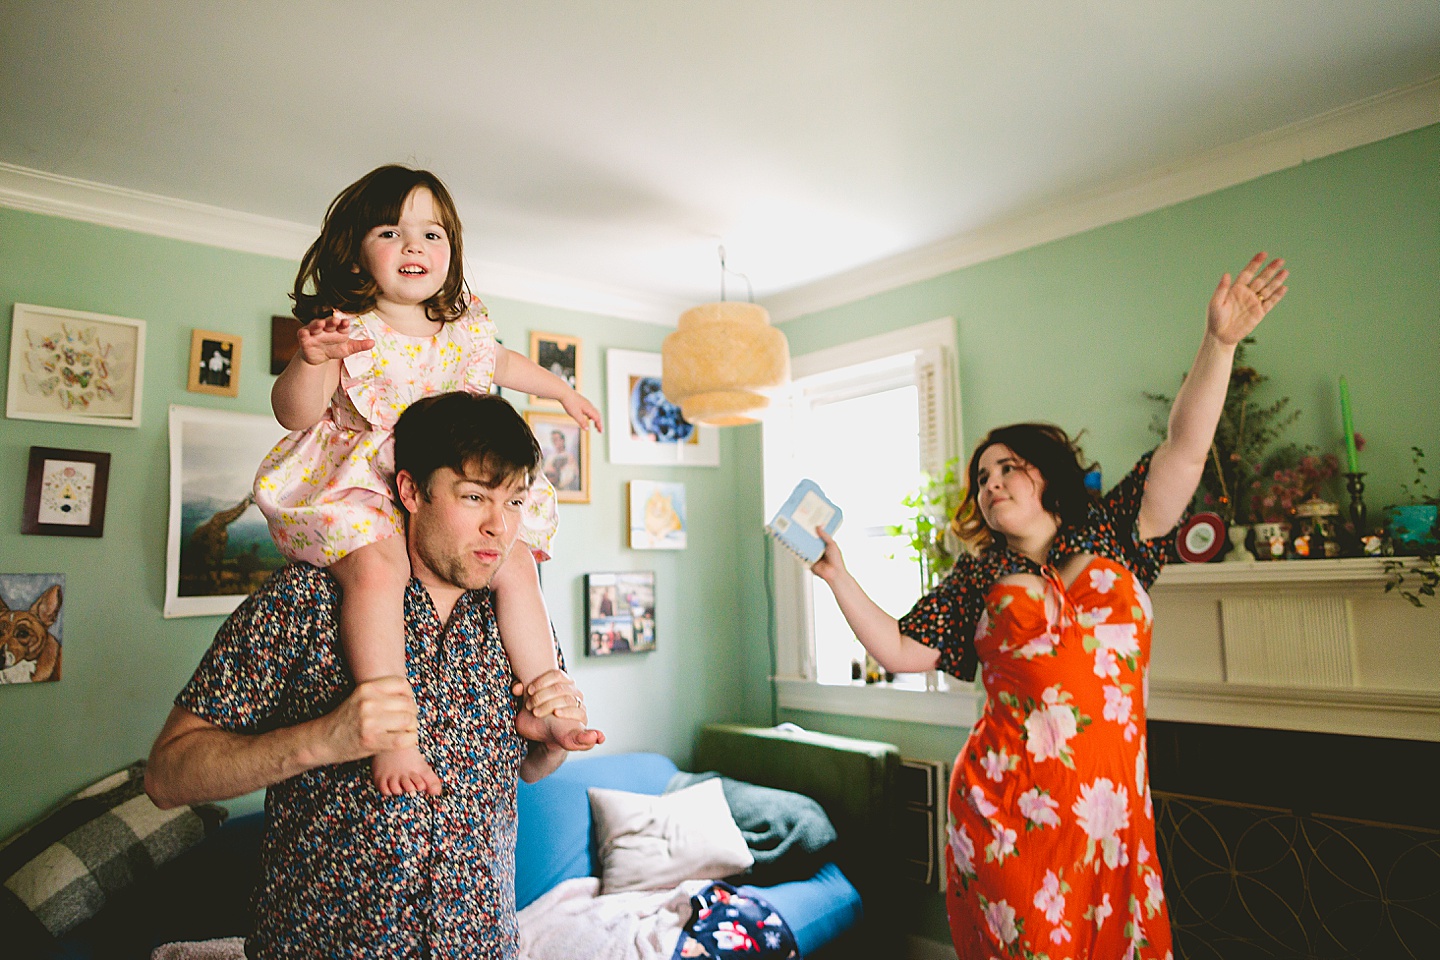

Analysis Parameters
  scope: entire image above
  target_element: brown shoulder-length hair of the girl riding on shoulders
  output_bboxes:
[289,164,469,324]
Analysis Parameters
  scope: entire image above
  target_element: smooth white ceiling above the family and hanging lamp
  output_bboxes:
[0,0,1440,321]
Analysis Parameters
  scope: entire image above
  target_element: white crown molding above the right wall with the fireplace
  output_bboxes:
[762,76,1440,322]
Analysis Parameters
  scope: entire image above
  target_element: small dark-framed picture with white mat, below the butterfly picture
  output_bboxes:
[20,446,109,537]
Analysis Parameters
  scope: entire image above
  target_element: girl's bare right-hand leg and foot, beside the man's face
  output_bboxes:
[490,541,600,750]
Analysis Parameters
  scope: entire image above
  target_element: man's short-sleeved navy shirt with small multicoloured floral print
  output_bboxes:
[176,564,541,960]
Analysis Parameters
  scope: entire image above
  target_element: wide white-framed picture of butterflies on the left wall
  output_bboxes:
[4,304,145,427]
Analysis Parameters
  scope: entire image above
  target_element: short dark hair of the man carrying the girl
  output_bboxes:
[395,390,540,498]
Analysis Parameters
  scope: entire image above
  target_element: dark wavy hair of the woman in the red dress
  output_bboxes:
[950,423,1094,554]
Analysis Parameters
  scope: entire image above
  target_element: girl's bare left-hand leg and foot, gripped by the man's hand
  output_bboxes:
[330,537,441,796]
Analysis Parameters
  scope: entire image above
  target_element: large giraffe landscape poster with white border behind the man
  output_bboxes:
[164,404,287,617]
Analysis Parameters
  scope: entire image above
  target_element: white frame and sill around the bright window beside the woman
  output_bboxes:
[762,317,982,727]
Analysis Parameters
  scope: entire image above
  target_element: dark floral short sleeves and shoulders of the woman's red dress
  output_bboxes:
[900,450,1176,679]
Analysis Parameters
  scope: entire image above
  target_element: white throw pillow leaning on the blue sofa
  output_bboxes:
[589,779,755,894]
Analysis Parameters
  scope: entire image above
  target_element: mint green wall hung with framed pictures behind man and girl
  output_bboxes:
[0,209,769,838]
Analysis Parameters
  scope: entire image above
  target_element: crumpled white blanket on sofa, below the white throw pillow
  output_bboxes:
[518,877,710,960]
